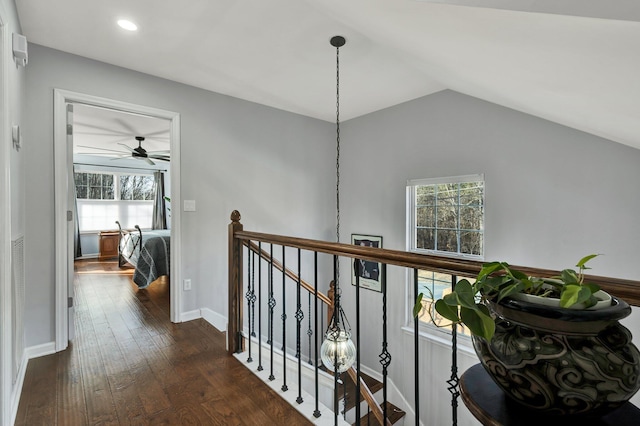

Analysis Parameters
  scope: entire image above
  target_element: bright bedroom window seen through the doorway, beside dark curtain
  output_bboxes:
[75,172,155,231]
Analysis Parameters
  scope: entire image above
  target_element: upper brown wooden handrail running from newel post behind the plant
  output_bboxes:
[234,231,640,306]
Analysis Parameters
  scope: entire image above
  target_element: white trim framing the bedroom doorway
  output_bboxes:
[53,89,182,352]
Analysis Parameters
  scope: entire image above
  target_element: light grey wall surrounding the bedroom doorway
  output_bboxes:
[25,45,334,346]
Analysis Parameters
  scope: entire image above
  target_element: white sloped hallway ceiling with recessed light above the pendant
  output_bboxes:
[16,0,640,148]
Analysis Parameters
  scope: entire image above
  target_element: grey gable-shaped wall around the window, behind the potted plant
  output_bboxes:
[341,91,640,425]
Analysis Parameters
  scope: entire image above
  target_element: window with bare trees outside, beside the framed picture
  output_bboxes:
[407,175,484,334]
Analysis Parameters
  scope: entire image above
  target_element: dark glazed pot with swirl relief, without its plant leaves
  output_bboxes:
[473,298,640,416]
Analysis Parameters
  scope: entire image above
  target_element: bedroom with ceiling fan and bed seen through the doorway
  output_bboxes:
[72,103,171,288]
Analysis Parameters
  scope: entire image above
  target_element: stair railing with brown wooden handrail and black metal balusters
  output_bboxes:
[227,210,640,425]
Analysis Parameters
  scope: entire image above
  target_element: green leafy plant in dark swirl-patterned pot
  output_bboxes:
[414,255,640,416]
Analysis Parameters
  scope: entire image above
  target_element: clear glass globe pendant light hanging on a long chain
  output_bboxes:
[320,36,356,373]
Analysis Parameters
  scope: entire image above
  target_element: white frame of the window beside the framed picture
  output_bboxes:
[404,174,486,340]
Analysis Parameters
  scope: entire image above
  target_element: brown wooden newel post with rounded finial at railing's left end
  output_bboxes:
[227,210,244,354]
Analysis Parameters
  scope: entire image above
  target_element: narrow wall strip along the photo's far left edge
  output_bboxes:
[0,0,26,425]
